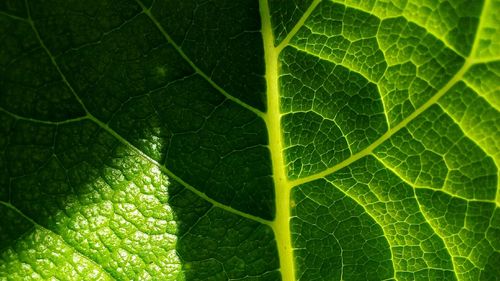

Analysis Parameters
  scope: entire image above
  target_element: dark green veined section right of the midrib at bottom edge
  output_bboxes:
[291,180,394,281]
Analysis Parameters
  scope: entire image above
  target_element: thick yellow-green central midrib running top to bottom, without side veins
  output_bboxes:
[259,0,295,281]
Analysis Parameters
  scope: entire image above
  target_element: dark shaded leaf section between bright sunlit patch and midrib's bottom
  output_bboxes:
[169,183,281,281]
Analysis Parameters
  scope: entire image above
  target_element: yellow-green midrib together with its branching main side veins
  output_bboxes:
[0,0,498,280]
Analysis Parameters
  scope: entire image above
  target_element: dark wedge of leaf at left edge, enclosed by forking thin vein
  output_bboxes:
[0,17,85,121]
